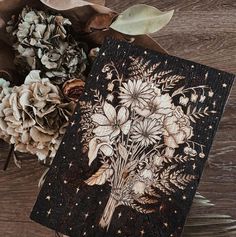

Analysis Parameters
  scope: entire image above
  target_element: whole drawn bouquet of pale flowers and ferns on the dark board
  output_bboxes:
[81,57,215,230]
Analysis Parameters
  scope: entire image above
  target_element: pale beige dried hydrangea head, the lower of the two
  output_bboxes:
[0,70,75,160]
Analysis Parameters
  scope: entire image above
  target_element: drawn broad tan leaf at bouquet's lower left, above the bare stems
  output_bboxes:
[85,163,113,186]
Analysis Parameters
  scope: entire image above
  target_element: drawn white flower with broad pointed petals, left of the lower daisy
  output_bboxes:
[92,102,131,139]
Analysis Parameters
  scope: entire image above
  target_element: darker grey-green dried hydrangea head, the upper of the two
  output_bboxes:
[7,7,87,84]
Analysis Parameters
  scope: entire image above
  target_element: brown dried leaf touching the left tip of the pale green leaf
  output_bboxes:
[84,13,117,32]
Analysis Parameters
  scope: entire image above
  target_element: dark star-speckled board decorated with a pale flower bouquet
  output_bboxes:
[31,40,234,237]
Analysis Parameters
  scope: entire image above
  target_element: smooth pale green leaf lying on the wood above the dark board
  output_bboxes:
[110,4,174,35]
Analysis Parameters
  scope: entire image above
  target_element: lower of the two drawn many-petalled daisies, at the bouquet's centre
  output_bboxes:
[132,118,162,146]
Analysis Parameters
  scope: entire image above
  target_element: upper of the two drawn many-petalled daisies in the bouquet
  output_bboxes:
[119,80,154,108]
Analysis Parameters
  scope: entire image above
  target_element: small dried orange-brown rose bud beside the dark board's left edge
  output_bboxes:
[62,79,85,101]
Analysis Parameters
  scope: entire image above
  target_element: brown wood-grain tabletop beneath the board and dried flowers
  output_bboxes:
[0,0,236,237]
